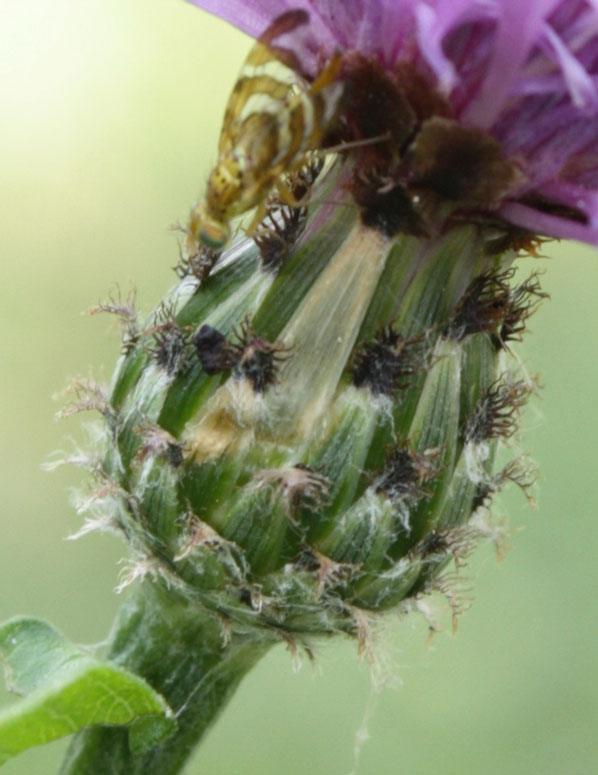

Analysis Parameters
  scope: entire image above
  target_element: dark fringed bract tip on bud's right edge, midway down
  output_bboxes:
[464,378,534,443]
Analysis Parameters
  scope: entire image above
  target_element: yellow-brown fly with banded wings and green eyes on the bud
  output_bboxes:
[188,9,343,250]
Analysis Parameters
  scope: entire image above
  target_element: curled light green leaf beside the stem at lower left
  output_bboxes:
[0,618,176,764]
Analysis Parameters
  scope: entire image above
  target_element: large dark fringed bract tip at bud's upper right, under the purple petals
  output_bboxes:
[444,269,514,341]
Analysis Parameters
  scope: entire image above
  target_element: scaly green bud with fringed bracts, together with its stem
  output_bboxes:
[56,144,541,775]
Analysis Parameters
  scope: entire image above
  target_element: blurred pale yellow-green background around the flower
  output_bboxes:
[0,0,598,775]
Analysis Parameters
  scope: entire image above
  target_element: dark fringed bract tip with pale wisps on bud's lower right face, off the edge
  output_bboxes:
[375,446,441,503]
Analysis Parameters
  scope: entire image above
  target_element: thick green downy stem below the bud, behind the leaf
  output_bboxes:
[61,581,276,775]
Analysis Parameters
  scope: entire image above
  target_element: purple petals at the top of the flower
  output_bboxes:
[190,0,598,244]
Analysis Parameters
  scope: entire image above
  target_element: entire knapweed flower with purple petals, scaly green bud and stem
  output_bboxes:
[65,0,598,773]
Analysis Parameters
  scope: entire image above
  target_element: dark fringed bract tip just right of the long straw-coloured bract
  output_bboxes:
[352,326,429,396]
